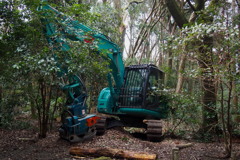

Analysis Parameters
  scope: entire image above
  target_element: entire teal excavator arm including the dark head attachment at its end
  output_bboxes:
[38,1,124,142]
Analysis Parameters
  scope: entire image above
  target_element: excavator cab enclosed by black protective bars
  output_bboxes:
[119,64,164,118]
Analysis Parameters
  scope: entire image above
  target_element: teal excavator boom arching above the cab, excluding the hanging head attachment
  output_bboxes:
[39,2,124,108]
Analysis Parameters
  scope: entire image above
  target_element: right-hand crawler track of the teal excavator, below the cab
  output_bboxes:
[144,120,162,142]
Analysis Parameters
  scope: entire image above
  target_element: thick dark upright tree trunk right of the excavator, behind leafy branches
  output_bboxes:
[198,36,218,133]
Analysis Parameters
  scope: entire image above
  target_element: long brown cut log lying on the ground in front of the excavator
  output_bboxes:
[69,147,157,160]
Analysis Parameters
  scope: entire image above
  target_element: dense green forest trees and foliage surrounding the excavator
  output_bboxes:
[0,0,240,158]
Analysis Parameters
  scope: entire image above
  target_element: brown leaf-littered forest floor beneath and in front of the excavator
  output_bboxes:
[0,125,240,160]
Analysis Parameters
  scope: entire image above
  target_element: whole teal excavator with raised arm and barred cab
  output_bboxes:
[39,0,168,142]
